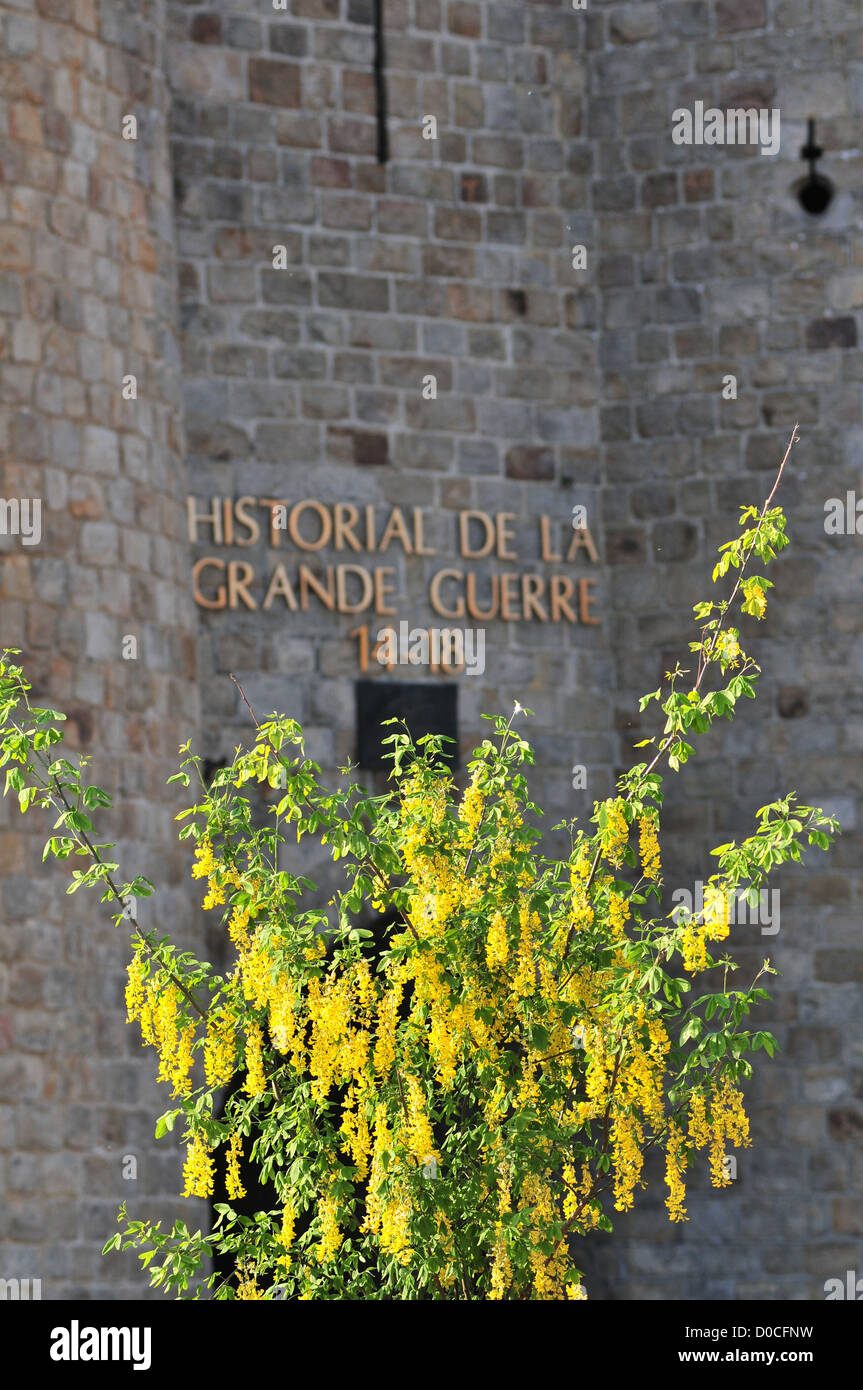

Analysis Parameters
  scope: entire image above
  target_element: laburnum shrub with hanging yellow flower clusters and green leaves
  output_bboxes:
[0,439,837,1300]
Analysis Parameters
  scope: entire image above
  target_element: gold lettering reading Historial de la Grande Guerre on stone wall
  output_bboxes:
[186,496,600,671]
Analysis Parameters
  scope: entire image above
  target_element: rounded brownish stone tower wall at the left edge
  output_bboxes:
[0,0,197,1298]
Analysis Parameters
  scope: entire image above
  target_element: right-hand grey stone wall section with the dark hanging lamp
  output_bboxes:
[585,0,863,1298]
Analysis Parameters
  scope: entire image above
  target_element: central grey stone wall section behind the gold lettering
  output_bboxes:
[170,0,614,889]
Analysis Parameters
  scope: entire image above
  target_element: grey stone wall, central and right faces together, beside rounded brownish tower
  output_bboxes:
[174,0,863,1298]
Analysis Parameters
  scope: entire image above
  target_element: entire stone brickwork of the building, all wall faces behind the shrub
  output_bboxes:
[0,0,863,1300]
